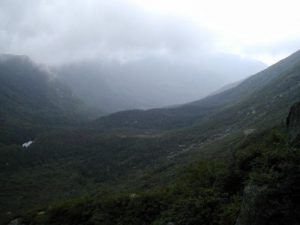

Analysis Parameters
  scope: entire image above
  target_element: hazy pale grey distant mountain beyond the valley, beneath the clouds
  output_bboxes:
[55,54,265,113]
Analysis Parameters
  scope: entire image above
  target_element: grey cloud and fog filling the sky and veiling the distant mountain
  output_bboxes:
[0,0,299,112]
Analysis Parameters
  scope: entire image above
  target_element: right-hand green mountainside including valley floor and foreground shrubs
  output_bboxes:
[0,52,300,225]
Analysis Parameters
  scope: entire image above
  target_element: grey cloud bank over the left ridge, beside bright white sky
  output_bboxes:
[0,0,219,63]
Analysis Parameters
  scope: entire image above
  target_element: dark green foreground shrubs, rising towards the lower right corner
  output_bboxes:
[12,128,300,225]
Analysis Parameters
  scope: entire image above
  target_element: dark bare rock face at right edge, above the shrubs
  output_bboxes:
[287,102,300,145]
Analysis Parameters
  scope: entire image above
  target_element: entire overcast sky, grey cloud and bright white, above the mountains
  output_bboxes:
[0,0,300,64]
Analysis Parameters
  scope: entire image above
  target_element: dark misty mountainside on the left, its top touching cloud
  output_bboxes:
[0,55,85,143]
